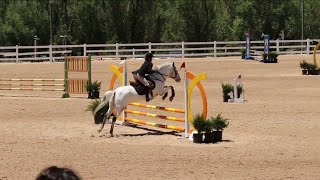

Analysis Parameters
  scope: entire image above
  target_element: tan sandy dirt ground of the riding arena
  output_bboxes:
[0,55,320,180]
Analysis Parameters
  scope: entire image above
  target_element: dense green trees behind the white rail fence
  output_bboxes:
[0,0,320,46]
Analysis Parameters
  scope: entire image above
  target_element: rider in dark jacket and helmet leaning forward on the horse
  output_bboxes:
[132,52,154,102]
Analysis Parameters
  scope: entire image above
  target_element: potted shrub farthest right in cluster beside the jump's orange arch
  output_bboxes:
[211,113,229,142]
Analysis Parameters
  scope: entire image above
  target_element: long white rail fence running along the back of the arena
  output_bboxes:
[0,39,319,62]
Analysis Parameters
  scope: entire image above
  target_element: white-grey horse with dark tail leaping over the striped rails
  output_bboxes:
[94,62,181,137]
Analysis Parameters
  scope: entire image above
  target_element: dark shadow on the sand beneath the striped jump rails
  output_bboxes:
[122,123,181,137]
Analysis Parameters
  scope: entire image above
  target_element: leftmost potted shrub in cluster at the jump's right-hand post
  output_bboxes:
[192,114,206,143]
